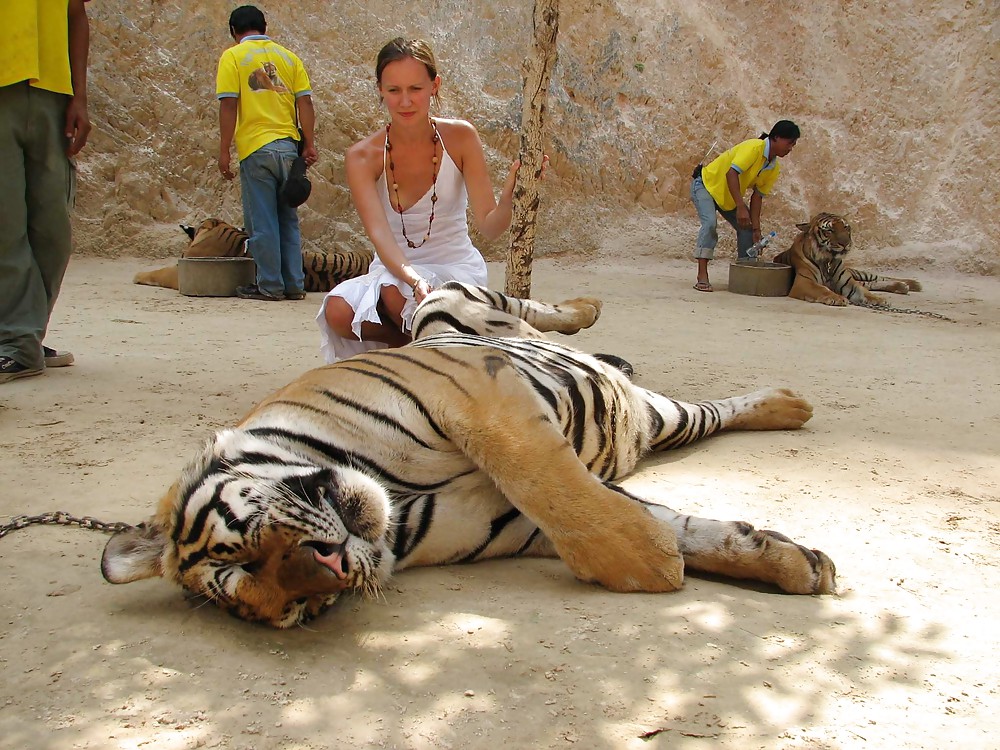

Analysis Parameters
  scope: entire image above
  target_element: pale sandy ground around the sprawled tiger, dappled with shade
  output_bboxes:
[0,253,1000,750]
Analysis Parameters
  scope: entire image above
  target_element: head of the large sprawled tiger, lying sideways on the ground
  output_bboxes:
[101,428,392,628]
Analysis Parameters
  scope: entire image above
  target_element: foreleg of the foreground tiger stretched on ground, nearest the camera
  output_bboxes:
[646,503,837,594]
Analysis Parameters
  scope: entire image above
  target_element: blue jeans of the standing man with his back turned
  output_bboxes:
[240,138,305,297]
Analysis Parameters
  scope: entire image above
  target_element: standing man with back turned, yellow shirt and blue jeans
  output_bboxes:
[216,5,317,300]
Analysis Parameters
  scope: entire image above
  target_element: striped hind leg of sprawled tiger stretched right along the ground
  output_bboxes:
[636,388,812,451]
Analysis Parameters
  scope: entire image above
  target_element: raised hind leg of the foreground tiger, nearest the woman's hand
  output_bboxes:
[413,281,601,339]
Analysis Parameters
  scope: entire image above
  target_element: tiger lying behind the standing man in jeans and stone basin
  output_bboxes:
[132,219,374,292]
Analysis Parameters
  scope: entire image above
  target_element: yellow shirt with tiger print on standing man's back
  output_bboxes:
[215,34,312,161]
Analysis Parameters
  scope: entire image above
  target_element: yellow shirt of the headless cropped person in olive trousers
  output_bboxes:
[6,0,81,96]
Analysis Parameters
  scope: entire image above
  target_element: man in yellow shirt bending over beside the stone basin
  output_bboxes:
[691,120,799,292]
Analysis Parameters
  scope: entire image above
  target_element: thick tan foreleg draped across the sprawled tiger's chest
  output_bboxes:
[419,348,684,592]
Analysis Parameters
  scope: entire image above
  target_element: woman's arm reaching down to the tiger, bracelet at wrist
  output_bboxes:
[344,131,426,291]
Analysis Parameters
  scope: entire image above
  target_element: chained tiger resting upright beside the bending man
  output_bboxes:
[774,213,921,306]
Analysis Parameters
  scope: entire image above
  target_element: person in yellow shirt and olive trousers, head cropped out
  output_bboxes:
[0,0,90,383]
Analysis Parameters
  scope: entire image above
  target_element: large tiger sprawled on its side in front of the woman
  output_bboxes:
[101,282,835,628]
